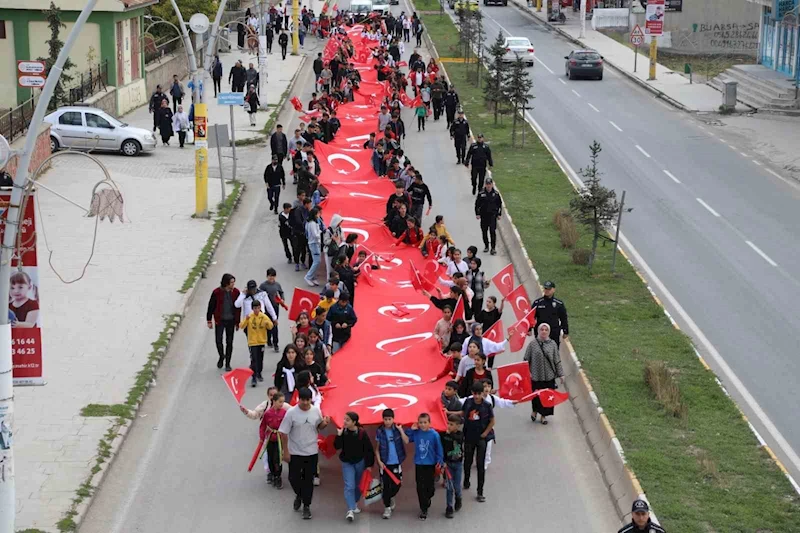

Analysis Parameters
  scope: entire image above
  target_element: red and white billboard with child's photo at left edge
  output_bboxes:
[0,191,44,385]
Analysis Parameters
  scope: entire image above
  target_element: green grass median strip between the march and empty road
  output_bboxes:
[422,9,800,533]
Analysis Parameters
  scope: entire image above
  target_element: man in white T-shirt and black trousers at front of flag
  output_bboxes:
[278,387,331,520]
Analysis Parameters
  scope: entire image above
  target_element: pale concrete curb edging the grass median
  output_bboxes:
[416,6,659,524]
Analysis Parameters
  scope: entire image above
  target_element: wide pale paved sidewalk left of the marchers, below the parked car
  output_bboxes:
[14,46,306,531]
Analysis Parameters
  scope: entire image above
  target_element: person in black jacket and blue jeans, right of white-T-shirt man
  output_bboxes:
[333,411,375,522]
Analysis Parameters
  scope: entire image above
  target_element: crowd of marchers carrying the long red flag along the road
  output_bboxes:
[207,8,660,531]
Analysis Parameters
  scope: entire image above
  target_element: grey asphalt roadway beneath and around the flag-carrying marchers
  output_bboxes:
[80,20,619,533]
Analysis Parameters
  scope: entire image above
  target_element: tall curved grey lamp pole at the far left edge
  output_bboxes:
[0,0,97,533]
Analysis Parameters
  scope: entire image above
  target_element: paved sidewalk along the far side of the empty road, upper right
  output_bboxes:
[510,0,751,113]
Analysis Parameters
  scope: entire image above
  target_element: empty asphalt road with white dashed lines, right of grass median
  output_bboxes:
[466,5,800,475]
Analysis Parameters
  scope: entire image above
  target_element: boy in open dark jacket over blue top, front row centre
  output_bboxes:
[375,409,409,520]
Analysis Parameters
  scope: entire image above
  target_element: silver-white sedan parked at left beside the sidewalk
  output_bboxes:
[44,106,156,156]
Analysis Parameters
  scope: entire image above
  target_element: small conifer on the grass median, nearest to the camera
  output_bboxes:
[569,141,619,273]
